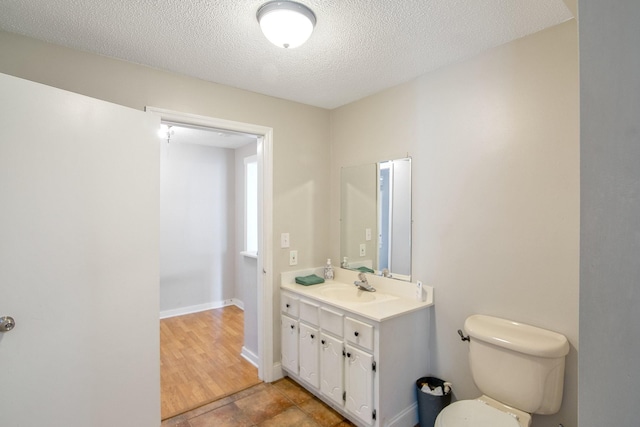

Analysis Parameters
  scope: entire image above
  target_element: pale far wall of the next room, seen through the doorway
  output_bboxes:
[158,140,237,313]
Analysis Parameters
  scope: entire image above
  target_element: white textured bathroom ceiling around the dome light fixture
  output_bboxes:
[0,0,573,108]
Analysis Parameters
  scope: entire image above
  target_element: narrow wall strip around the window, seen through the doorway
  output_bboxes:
[235,143,258,361]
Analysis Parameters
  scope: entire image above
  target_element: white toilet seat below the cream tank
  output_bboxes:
[435,400,522,427]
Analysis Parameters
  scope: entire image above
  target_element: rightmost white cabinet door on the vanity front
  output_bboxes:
[345,345,373,424]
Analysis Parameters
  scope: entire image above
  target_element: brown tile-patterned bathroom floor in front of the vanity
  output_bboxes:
[161,377,353,427]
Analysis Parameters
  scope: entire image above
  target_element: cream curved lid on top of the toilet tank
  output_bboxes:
[464,314,569,357]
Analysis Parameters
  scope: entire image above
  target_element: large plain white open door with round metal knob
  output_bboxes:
[0,74,160,427]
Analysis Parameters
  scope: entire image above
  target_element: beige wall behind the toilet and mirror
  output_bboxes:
[331,21,579,427]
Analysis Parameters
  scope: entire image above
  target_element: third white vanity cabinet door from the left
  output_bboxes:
[320,334,344,406]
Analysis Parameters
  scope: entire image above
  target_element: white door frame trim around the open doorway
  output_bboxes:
[145,107,276,382]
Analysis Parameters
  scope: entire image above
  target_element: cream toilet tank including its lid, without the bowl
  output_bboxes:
[464,314,569,414]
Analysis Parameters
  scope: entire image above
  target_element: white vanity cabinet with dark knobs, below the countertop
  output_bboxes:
[281,291,428,427]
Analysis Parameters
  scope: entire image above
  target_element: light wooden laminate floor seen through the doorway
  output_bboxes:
[160,306,260,420]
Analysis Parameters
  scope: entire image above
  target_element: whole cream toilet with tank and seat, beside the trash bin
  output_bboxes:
[435,314,569,427]
